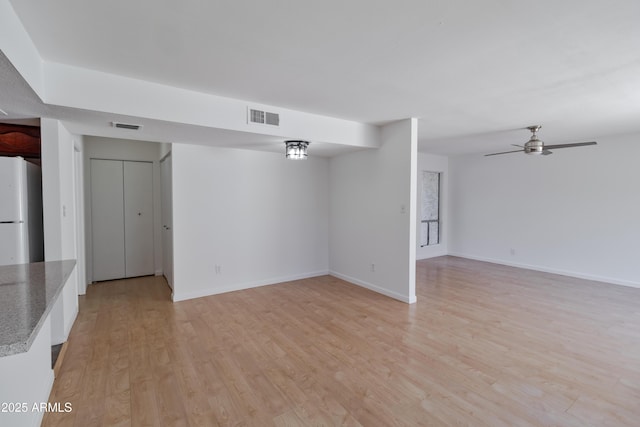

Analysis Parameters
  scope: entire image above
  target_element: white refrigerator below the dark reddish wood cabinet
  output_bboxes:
[0,157,44,265]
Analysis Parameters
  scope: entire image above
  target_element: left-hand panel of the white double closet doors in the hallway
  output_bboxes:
[91,159,125,281]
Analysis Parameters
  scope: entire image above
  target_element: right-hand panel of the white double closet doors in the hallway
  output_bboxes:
[124,161,154,277]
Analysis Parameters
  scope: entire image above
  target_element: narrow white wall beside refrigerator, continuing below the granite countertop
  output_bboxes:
[40,118,83,344]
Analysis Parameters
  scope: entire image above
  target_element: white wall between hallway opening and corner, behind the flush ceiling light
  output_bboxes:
[172,144,329,301]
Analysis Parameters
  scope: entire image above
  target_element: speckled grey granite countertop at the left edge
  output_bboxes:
[0,260,76,357]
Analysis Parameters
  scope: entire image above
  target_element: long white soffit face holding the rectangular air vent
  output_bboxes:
[43,62,379,147]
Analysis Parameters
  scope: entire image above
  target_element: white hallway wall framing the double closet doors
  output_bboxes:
[84,136,162,283]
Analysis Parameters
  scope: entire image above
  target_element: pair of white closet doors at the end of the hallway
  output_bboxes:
[91,159,154,281]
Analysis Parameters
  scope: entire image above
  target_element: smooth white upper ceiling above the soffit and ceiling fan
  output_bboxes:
[3,0,640,154]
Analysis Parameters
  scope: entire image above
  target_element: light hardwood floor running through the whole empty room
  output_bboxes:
[43,257,640,427]
